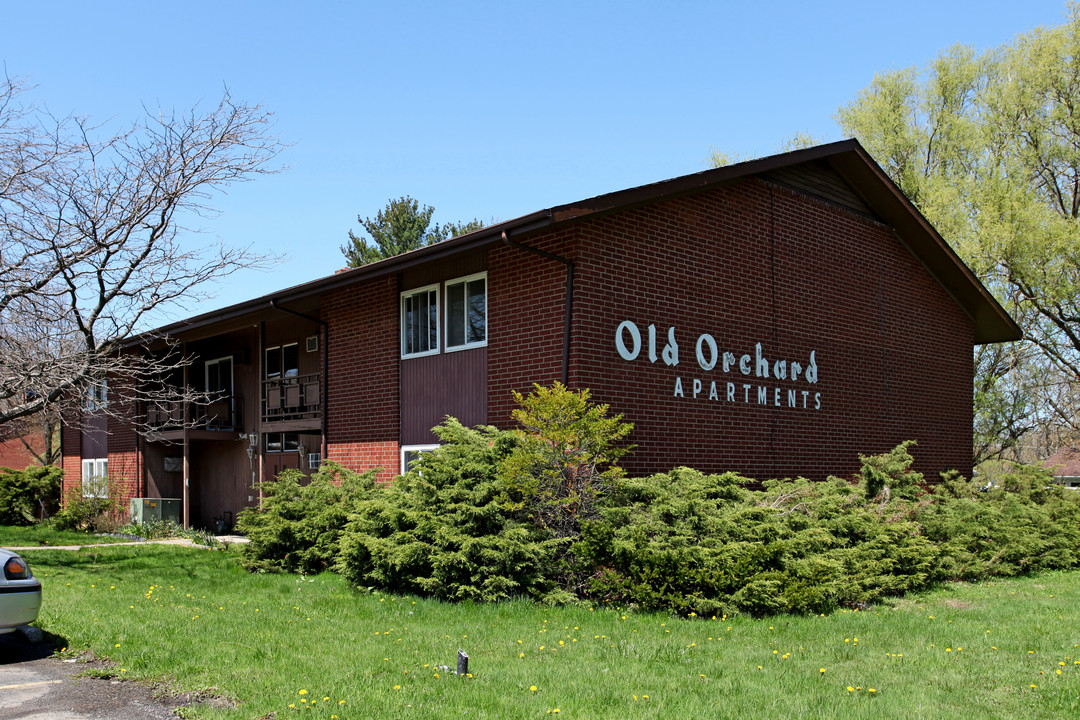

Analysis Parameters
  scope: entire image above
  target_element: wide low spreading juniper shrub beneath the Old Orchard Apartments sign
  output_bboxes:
[578,467,934,615]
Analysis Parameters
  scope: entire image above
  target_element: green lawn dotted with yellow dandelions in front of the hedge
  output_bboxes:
[14,546,1080,720]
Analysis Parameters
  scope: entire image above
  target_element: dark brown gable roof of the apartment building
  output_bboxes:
[145,139,1023,344]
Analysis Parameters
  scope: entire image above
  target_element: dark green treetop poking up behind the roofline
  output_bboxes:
[341,195,484,268]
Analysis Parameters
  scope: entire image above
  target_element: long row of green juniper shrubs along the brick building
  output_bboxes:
[240,420,1080,615]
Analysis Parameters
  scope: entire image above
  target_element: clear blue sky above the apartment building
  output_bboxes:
[0,0,1065,322]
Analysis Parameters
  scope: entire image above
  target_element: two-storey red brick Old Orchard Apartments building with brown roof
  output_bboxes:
[64,140,1021,526]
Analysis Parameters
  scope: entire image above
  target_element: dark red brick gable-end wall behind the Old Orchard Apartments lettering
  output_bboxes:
[561,180,973,479]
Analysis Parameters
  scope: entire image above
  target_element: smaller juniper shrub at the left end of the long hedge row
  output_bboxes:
[237,461,376,573]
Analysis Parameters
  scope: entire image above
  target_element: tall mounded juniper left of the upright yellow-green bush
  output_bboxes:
[338,418,557,601]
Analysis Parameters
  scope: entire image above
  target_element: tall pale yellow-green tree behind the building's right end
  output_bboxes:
[838,3,1080,462]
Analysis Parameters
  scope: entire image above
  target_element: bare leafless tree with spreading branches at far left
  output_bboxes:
[0,79,282,424]
